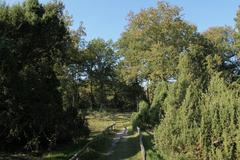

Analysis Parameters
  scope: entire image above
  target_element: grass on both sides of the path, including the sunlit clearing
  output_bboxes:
[0,112,158,160]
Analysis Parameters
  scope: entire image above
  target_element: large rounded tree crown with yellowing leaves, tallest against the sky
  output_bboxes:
[119,2,197,83]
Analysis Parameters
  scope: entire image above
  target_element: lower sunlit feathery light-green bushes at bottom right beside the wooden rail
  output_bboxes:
[154,76,240,159]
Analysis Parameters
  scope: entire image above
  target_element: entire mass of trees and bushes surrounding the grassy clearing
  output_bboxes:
[0,0,240,159]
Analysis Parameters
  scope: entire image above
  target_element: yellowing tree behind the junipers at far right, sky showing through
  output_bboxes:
[203,27,239,81]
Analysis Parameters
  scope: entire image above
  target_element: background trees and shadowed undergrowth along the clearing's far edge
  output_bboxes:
[75,39,144,110]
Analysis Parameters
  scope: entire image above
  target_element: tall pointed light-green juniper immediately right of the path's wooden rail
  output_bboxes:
[154,45,209,159]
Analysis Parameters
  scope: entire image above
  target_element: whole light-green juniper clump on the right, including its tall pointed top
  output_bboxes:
[152,24,239,159]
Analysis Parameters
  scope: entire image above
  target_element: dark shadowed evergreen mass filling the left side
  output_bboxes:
[0,0,88,150]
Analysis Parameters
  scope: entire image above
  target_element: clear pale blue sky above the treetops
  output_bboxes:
[5,0,240,41]
